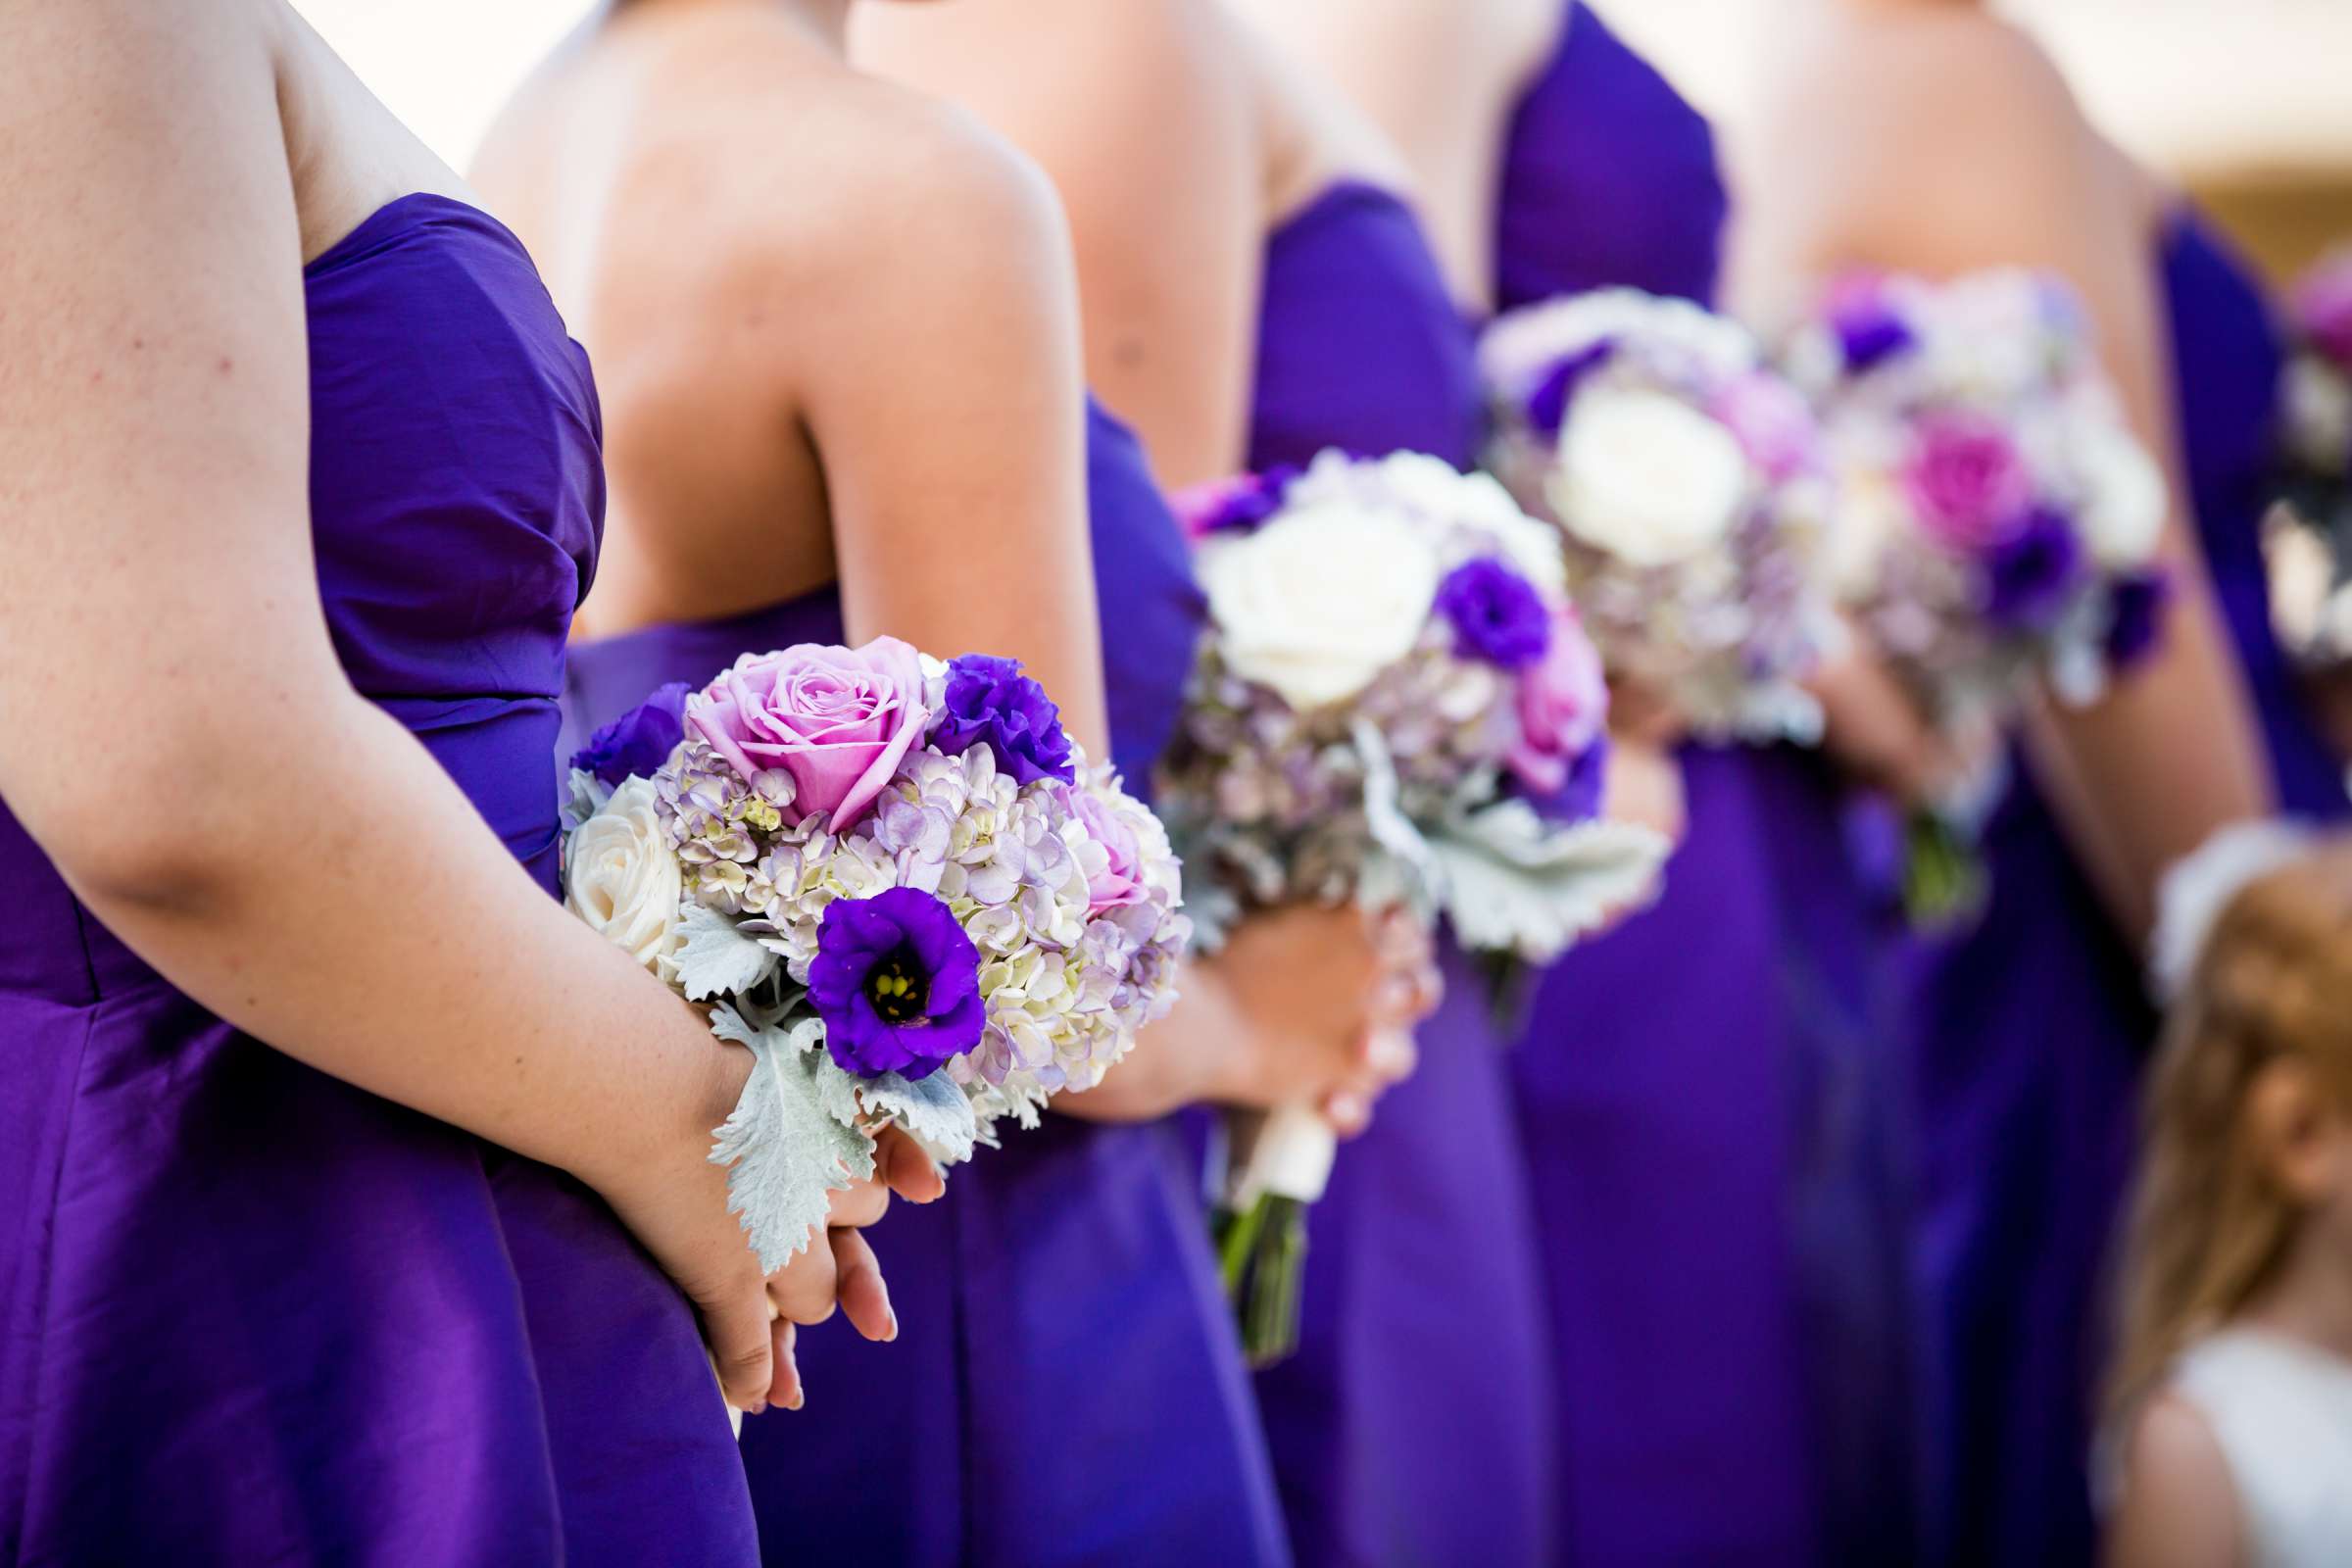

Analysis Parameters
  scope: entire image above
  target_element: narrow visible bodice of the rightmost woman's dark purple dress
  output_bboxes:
[2162,209,2347,815]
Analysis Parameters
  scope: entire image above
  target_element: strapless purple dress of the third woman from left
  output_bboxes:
[1249,183,1552,1563]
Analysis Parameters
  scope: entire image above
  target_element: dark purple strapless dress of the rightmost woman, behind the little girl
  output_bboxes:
[1919,214,2347,1563]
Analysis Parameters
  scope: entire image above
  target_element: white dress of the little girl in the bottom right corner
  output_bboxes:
[2174,1328,2352,1568]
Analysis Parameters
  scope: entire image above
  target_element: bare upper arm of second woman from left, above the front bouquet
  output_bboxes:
[793,104,1107,757]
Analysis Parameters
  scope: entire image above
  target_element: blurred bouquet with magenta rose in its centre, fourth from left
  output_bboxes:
[1786,270,2166,924]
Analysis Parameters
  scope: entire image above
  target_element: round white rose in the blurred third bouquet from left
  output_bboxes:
[1547,385,1750,566]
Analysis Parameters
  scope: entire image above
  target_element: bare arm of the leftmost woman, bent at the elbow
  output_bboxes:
[0,0,865,1405]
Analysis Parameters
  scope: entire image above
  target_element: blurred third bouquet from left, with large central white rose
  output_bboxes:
[1480,289,1841,743]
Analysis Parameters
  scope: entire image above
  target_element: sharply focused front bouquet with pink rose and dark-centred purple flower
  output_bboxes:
[564,637,1190,1269]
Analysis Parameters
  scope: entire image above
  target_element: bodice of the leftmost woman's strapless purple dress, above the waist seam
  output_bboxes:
[0,195,605,1002]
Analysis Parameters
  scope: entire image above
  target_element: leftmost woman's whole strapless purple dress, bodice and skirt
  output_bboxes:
[0,195,755,1566]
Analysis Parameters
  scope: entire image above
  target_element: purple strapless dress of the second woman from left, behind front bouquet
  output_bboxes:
[566,405,1289,1568]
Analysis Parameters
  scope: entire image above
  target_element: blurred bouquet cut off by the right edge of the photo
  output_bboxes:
[2263,249,2352,665]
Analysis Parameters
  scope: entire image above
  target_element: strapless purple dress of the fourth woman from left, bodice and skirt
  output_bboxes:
[1494,5,1917,1563]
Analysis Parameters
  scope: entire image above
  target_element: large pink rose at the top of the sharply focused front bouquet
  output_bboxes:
[687,637,931,832]
